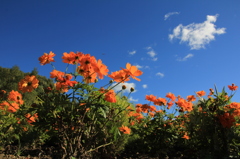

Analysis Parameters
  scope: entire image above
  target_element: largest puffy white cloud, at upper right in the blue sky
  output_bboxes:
[169,15,226,50]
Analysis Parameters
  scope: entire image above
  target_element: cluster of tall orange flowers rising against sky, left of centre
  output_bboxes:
[39,52,143,98]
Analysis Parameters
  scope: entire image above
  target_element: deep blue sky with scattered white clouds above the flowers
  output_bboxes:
[0,0,240,103]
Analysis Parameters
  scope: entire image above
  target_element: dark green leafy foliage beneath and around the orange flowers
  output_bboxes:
[0,66,240,159]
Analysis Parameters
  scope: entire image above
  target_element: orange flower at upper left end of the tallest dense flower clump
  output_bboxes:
[62,52,83,65]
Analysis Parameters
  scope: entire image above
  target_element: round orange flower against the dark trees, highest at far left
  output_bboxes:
[18,75,39,93]
